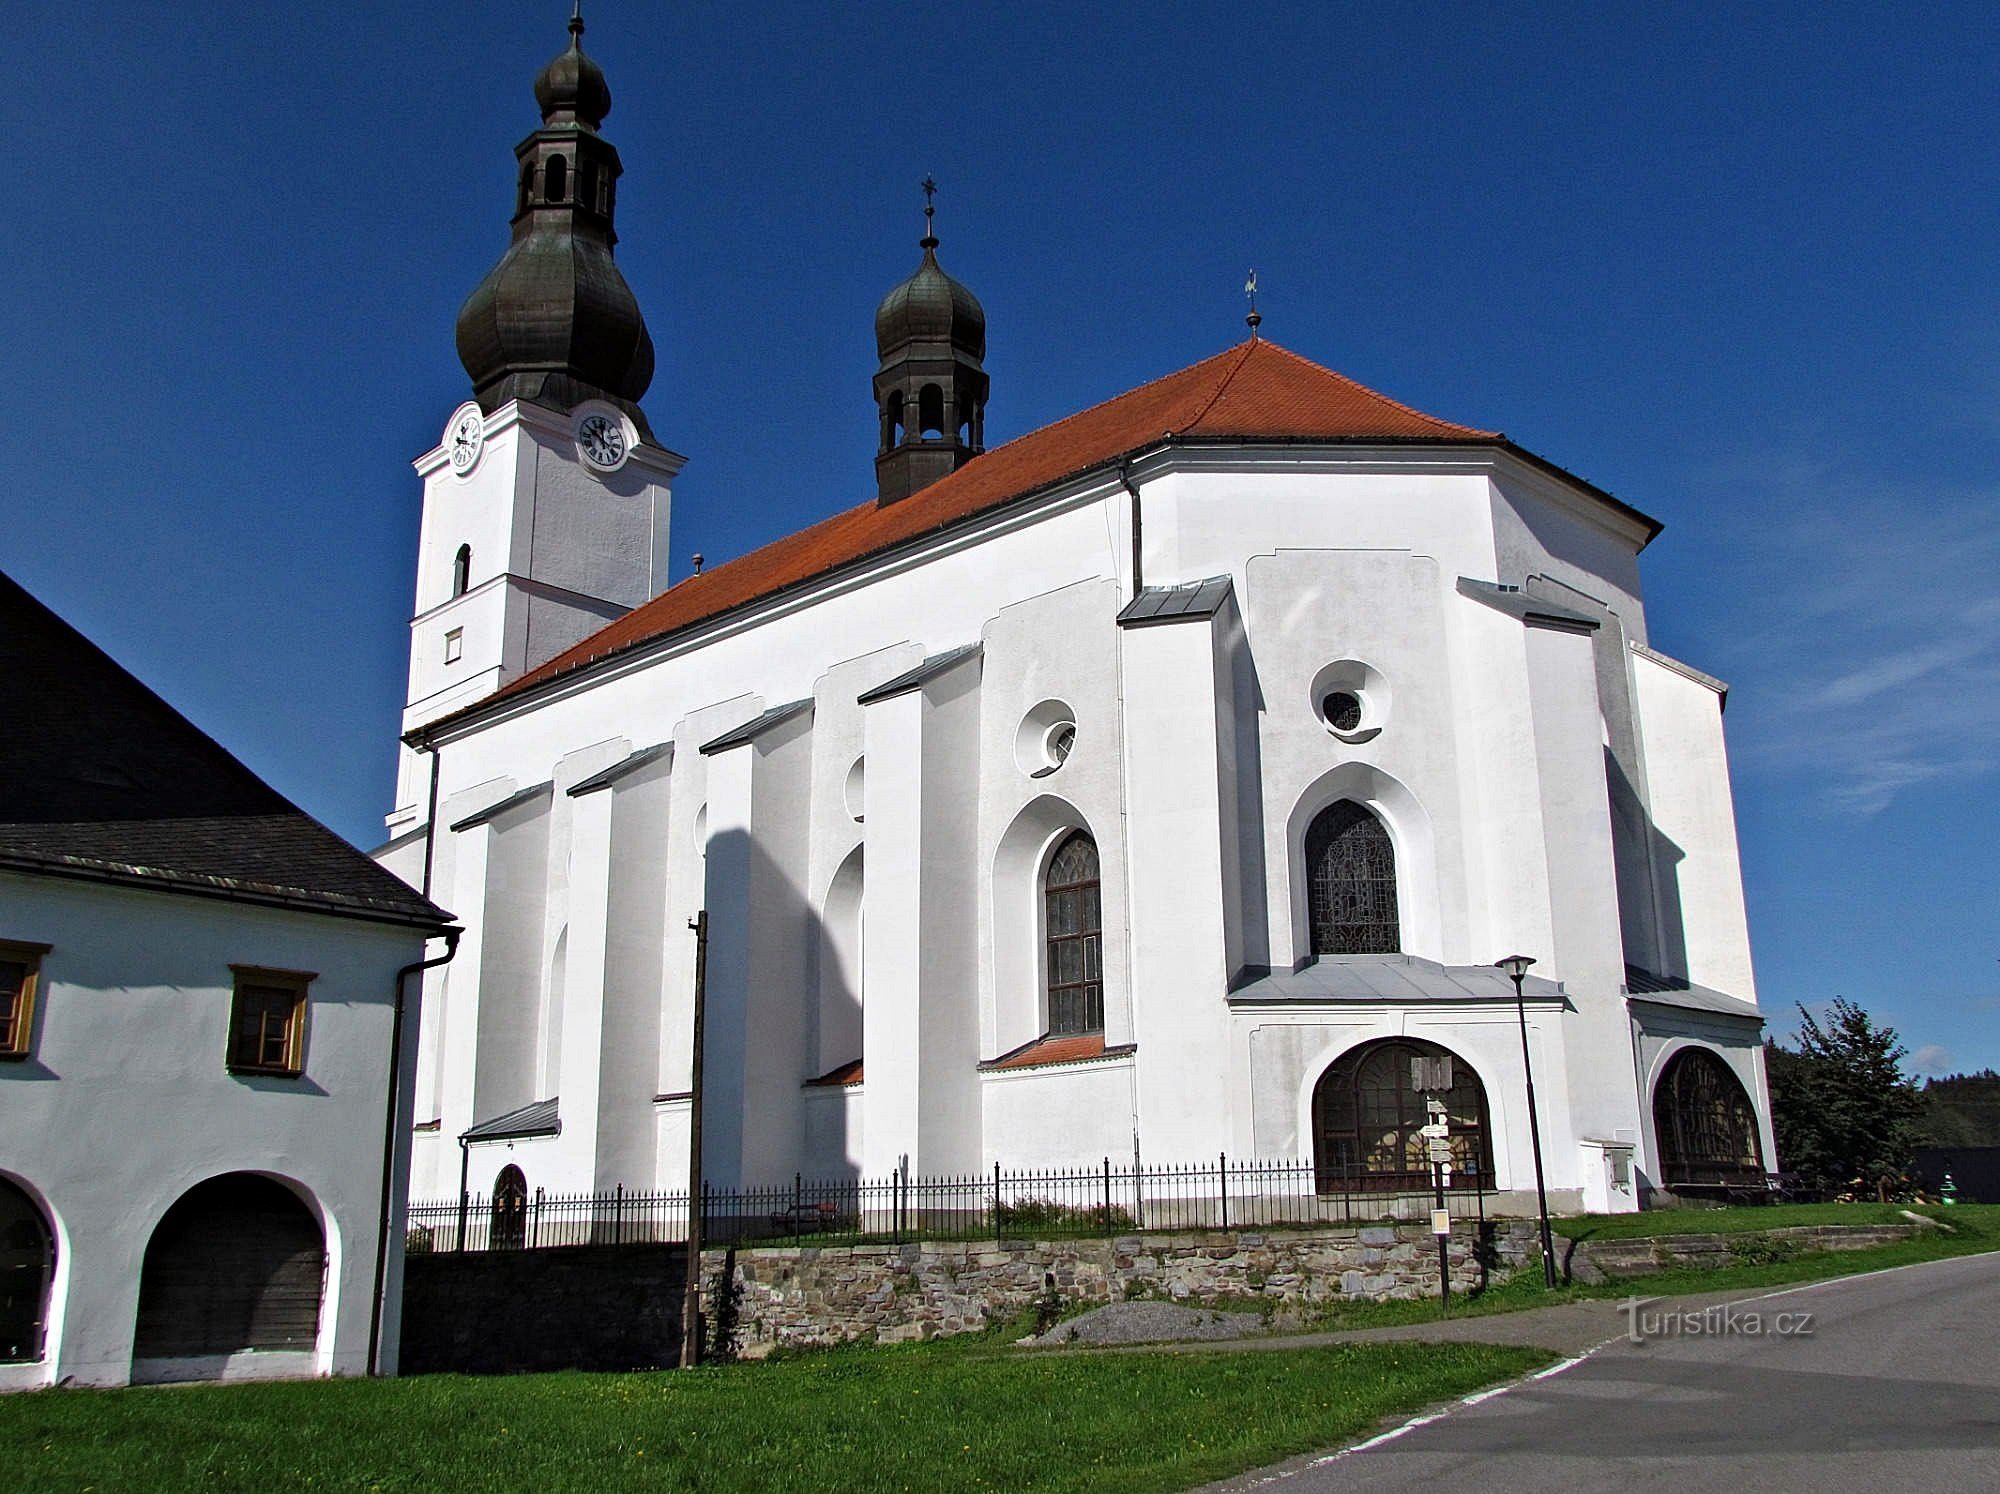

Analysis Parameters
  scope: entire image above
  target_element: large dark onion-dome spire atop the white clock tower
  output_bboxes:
[458,14,654,440]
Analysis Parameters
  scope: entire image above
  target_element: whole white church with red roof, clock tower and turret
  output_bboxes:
[382,14,1776,1210]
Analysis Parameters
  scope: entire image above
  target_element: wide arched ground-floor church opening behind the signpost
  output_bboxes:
[1312,1038,1492,1192]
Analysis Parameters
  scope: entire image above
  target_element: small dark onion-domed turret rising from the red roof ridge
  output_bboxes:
[874,178,988,504]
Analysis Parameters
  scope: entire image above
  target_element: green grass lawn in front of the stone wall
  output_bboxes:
[0,1344,1550,1494]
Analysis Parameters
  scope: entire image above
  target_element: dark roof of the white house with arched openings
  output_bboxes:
[0,574,452,928]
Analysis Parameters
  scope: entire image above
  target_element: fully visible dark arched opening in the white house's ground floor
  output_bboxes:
[132,1172,326,1360]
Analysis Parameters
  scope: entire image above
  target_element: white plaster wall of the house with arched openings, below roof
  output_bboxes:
[0,872,424,1388]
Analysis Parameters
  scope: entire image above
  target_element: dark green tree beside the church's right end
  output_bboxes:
[1764,996,1924,1184]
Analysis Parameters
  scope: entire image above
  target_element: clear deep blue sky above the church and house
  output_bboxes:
[0,0,2000,1070]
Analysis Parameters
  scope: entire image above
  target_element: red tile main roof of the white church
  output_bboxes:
[422,338,1616,726]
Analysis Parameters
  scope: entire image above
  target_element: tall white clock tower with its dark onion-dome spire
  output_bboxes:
[388,14,684,836]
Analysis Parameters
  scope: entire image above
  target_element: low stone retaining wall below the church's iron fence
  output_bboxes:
[704,1220,1536,1358]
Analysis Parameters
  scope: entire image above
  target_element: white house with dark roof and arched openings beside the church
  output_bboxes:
[0,576,448,1390]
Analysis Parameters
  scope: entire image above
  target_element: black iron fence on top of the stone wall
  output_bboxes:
[408,1156,1488,1252]
